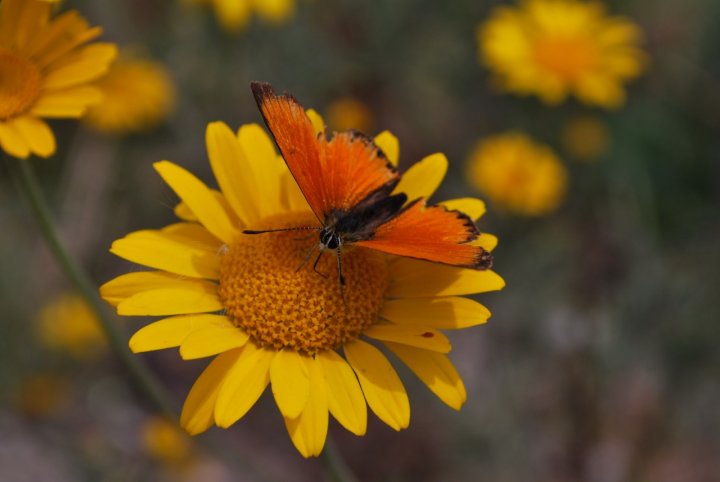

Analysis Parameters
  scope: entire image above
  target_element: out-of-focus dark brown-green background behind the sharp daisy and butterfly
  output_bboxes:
[0,0,720,482]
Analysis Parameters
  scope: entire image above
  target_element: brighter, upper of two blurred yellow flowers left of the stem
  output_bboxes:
[38,294,106,359]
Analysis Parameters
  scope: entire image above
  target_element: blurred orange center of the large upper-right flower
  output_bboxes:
[535,37,597,82]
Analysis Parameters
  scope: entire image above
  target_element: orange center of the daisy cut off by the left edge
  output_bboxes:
[0,50,41,120]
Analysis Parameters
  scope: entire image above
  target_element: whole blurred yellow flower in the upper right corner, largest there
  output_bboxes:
[477,0,646,108]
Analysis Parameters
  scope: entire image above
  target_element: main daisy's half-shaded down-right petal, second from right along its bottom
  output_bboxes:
[344,340,410,430]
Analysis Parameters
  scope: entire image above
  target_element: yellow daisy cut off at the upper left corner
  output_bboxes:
[0,0,117,159]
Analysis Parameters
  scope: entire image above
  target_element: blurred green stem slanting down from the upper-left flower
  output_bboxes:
[7,158,177,419]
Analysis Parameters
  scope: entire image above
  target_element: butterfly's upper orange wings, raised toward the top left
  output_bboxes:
[251,82,399,221]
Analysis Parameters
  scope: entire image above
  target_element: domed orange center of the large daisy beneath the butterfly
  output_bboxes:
[218,214,388,355]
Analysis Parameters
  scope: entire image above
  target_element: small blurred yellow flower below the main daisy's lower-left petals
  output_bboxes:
[142,416,194,469]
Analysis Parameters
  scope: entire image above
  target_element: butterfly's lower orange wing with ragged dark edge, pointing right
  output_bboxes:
[355,199,492,269]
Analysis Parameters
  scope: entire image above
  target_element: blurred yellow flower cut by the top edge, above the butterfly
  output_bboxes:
[188,0,295,33]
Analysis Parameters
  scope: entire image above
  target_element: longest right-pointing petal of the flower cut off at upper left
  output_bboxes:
[43,43,117,91]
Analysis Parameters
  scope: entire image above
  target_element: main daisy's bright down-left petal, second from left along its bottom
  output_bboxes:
[215,342,275,428]
